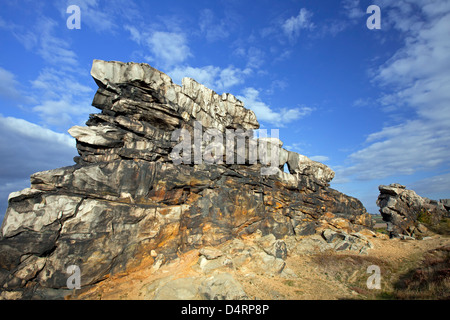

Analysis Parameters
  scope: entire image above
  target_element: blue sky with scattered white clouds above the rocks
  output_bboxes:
[0,0,450,218]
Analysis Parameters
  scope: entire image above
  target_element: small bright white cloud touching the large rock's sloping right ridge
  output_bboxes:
[237,88,313,127]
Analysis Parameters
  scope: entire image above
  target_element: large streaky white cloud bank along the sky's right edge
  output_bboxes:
[341,1,450,179]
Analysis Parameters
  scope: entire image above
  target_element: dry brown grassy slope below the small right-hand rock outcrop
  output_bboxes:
[306,237,450,300]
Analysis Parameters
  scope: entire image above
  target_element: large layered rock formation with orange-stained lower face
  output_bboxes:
[0,60,372,299]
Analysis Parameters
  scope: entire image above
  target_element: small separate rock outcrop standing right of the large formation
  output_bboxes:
[377,183,447,238]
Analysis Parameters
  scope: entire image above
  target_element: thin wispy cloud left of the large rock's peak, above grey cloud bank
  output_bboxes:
[0,10,95,129]
